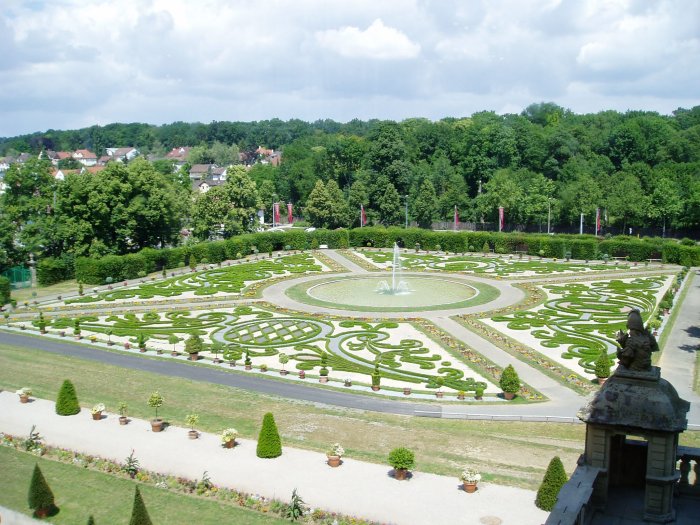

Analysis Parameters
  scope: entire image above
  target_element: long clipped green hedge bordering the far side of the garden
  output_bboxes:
[37,227,700,285]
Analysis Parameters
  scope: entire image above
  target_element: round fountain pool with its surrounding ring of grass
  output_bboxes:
[286,274,499,312]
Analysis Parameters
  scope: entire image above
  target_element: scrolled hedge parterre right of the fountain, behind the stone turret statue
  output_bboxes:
[492,276,669,374]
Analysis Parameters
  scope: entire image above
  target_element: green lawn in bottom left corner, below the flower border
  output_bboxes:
[0,447,285,525]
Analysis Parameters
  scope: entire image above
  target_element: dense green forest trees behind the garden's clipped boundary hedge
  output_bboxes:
[0,103,700,267]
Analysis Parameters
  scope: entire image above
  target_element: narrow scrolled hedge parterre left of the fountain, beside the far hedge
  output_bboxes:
[66,254,322,303]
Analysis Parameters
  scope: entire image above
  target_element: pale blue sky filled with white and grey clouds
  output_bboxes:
[0,0,700,136]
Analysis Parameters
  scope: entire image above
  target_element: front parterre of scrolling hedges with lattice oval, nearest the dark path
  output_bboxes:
[49,306,487,392]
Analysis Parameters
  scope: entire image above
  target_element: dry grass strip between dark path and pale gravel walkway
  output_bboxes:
[0,345,700,489]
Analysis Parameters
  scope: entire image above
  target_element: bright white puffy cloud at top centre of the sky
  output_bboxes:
[316,18,420,60]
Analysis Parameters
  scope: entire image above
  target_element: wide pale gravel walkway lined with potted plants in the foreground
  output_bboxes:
[0,392,547,525]
